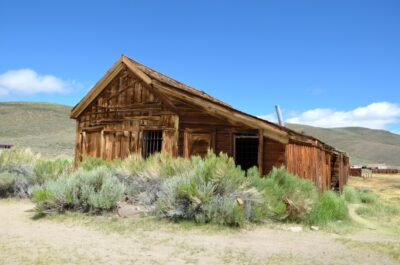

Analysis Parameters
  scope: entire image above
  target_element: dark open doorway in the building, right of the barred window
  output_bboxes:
[235,134,258,170]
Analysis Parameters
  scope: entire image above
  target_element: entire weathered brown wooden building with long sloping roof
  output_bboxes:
[71,55,349,190]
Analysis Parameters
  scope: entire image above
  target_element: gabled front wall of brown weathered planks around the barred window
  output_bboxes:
[75,68,179,162]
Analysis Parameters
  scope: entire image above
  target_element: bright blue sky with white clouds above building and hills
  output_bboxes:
[0,0,400,133]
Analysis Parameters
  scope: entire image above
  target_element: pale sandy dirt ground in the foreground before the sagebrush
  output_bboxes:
[0,201,398,264]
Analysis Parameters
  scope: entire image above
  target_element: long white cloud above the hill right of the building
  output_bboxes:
[285,102,400,129]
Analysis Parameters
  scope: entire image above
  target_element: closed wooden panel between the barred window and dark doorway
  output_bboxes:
[184,130,215,158]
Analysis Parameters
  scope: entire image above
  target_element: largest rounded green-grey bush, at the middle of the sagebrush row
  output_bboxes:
[156,152,263,226]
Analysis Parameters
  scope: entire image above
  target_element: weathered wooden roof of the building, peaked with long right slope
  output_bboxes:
[71,55,346,155]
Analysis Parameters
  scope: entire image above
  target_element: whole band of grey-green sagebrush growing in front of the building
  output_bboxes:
[0,149,354,226]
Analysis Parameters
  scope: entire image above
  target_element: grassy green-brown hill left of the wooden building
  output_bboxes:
[0,102,75,155]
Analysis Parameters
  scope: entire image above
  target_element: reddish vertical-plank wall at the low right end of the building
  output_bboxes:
[286,143,332,191]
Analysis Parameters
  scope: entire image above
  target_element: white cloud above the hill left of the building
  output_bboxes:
[0,69,79,96]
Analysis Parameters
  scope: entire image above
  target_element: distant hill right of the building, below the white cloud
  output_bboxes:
[286,124,400,166]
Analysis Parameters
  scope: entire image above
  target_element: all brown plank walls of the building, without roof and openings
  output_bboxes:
[75,67,349,190]
